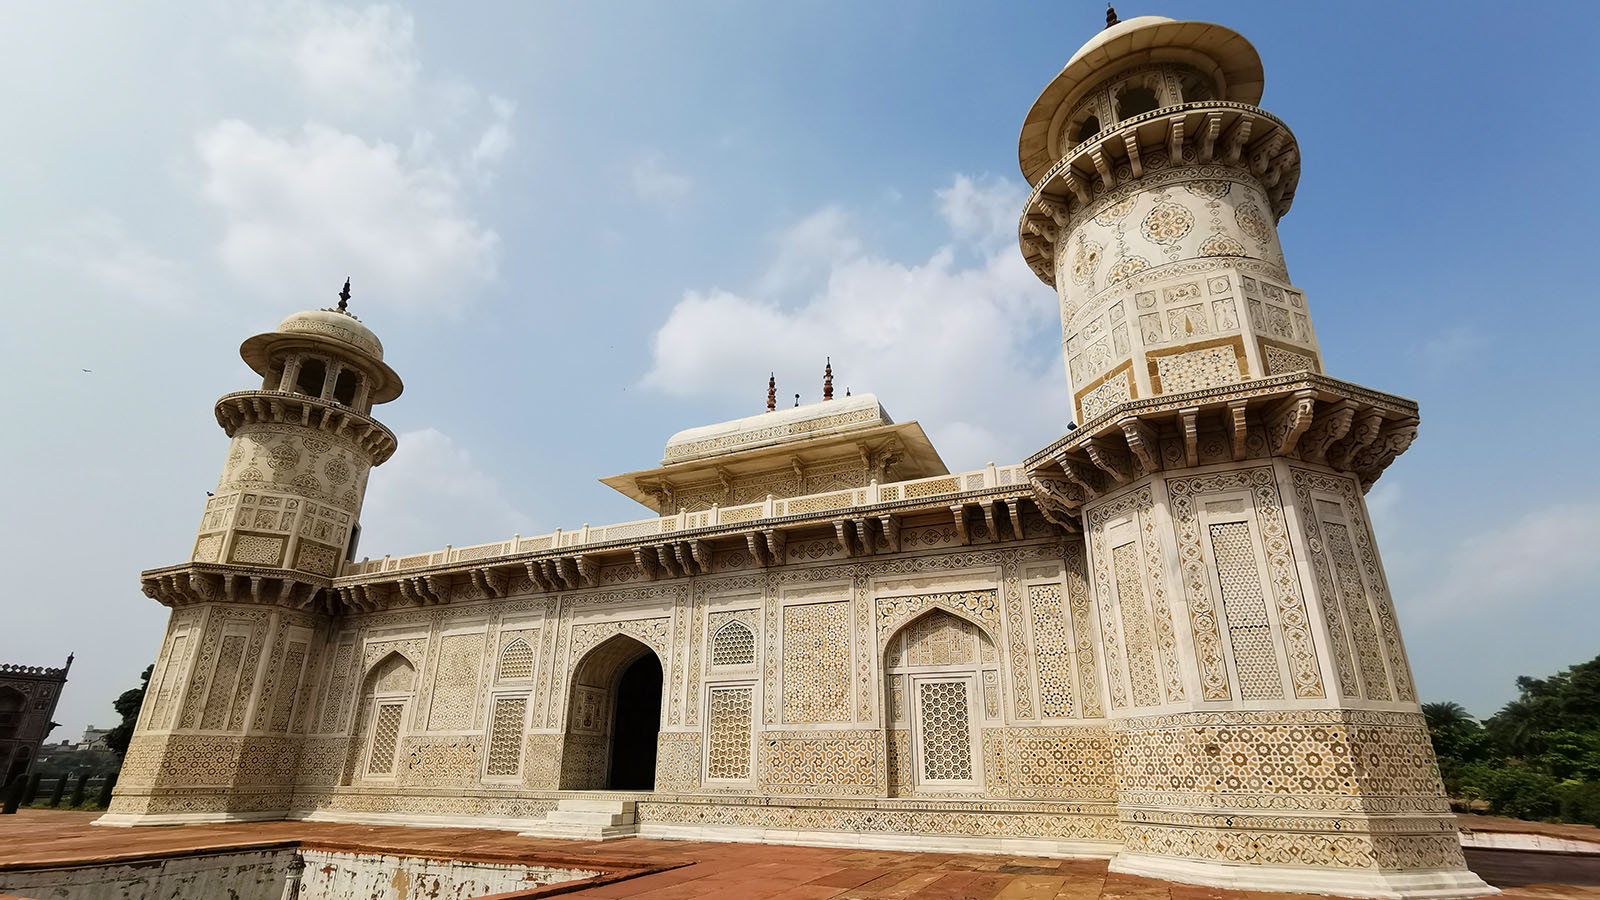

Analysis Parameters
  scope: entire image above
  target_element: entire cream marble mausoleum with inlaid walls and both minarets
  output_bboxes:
[101,16,1491,897]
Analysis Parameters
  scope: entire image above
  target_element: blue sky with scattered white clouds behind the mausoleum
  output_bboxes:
[0,2,1600,738]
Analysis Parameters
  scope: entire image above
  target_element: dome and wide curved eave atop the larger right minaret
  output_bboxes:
[1018,16,1264,184]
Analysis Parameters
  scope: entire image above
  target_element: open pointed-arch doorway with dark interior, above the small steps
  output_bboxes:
[562,634,661,791]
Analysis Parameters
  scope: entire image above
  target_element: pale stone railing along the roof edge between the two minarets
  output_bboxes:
[339,464,1027,577]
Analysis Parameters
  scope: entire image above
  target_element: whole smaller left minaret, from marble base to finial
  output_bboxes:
[101,282,402,825]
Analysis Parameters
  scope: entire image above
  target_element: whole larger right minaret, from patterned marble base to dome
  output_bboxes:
[1019,13,1493,897]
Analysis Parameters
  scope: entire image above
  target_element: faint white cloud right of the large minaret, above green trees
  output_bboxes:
[1418,501,1600,617]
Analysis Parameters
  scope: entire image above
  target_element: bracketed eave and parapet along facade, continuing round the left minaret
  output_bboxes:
[141,466,1032,615]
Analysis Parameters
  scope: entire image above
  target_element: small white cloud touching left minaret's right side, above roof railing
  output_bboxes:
[360,428,531,557]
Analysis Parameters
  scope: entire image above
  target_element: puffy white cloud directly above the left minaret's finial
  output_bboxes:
[195,120,499,309]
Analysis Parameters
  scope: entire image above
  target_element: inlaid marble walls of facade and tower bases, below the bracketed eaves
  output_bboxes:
[103,460,1459,868]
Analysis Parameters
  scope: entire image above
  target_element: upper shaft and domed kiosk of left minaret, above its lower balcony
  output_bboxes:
[192,283,402,578]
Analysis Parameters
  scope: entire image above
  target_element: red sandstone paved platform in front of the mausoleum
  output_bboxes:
[0,810,1600,900]
